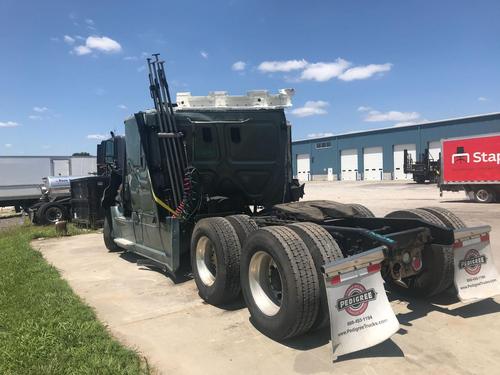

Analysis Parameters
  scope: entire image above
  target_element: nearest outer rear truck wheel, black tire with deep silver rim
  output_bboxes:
[241,226,320,340]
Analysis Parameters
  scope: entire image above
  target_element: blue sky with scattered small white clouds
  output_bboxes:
[0,0,500,155]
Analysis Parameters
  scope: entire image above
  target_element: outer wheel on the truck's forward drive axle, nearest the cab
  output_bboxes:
[191,217,241,306]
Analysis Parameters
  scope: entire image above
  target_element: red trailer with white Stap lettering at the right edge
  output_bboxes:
[439,134,500,203]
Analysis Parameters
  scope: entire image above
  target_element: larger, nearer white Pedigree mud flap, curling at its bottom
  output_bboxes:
[324,247,399,356]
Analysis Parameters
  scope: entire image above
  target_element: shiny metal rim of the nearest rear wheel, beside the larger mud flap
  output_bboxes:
[248,251,283,316]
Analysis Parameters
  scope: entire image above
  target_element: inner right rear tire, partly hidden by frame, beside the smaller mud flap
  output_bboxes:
[386,209,454,297]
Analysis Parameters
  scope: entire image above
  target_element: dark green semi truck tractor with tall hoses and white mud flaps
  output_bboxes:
[102,55,500,356]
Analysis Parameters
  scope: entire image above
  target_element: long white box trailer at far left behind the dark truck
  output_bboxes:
[0,156,97,209]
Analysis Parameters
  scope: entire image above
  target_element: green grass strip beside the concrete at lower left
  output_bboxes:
[0,225,149,375]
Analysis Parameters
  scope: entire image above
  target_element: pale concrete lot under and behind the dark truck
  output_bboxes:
[33,181,500,375]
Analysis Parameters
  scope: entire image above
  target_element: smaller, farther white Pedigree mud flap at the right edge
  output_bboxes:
[453,226,500,302]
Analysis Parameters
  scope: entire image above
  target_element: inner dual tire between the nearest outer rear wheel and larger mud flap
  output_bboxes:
[288,223,344,330]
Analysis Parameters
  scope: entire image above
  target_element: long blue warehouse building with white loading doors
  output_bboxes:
[292,113,500,181]
